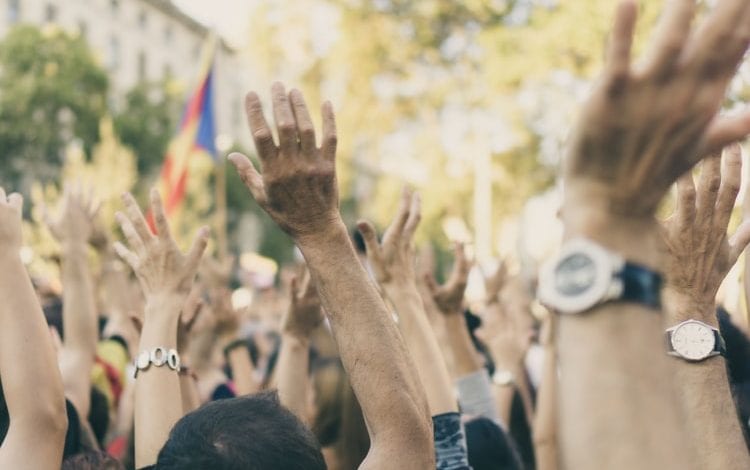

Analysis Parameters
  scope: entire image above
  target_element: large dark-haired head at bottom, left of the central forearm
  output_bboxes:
[156,392,326,470]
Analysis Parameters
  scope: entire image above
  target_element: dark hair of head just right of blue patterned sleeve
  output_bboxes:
[465,417,524,470]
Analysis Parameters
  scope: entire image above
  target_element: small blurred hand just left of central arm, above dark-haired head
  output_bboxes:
[281,270,323,340]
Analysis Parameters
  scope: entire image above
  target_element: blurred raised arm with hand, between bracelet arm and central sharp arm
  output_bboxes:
[275,272,323,423]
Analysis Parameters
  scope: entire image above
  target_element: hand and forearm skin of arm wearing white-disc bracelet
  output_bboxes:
[115,190,208,468]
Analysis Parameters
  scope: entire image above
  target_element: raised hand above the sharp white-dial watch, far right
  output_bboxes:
[663,144,750,324]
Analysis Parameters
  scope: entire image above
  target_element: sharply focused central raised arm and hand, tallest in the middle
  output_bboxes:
[229,83,435,469]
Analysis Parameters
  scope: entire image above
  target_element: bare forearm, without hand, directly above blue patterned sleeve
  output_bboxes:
[385,281,458,416]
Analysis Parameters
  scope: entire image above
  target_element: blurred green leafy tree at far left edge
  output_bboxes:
[0,26,108,190]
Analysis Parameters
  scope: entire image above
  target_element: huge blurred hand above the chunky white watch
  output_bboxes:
[562,0,750,239]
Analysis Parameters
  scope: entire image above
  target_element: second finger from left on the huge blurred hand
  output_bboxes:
[644,0,695,75]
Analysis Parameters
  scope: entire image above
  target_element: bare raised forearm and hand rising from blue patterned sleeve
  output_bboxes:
[358,189,458,416]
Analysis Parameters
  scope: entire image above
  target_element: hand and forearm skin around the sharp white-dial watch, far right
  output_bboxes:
[663,145,750,470]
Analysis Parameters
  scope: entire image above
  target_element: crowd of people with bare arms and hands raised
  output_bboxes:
[0,0,750,470]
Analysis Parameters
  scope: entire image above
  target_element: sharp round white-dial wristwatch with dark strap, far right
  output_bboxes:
[666,320,726,362]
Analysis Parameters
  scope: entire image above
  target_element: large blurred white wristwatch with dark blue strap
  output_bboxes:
[538,238,662,314]
